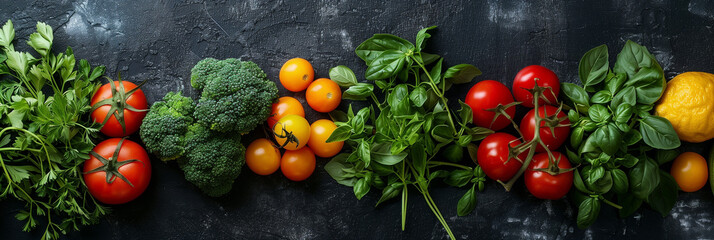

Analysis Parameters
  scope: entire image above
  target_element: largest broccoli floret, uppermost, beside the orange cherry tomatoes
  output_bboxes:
[191,58,278,134]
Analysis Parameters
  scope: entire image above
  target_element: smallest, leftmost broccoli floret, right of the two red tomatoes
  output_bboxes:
[139,92,194,161]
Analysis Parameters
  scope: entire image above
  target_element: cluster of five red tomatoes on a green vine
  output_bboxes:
[464,65,573,199]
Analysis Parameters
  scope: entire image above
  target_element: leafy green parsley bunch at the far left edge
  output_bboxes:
[0,20,109,239]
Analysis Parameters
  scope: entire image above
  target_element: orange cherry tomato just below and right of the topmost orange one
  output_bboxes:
[305,78,342,113]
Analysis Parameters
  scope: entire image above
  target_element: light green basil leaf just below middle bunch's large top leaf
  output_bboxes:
[364,50,407,80]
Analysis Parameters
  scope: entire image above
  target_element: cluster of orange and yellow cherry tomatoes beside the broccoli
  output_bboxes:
[245,58,344,181]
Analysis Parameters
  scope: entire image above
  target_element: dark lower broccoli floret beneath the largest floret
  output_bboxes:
[178,124,245,197]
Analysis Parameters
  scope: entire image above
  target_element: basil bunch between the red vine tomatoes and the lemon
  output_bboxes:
[563,41,680,228]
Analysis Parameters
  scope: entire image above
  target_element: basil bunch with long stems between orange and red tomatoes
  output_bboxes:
[325,27,486,239]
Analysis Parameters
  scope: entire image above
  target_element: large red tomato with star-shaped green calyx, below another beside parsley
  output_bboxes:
[82,138,151,204]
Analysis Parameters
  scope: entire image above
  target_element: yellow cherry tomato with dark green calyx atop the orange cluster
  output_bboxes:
[273,115,310,150]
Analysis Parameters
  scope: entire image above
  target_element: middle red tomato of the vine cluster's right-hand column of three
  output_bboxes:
[520,105,570,152]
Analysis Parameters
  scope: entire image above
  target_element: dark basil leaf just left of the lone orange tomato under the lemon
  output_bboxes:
[647,170,679,217]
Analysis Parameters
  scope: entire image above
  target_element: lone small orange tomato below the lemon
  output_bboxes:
[670,152,709,192]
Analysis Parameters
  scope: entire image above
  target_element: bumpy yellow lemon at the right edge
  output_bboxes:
[655,72,714,142]
